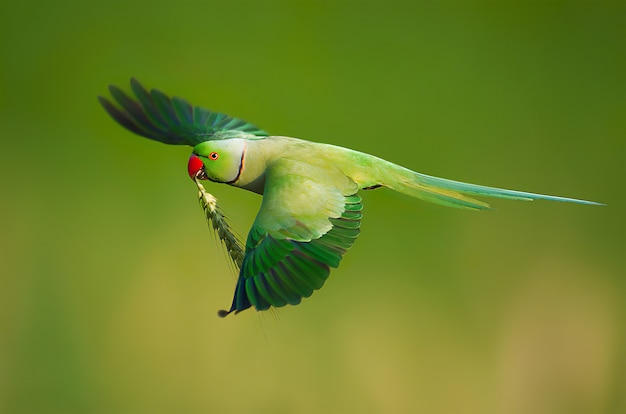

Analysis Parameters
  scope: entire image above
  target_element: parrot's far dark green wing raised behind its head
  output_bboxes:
[98,79,269,147]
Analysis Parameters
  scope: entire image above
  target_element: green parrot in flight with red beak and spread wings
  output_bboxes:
[98,78,602,317]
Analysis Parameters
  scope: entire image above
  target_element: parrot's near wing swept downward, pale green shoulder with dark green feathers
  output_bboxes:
[219,160,363,316]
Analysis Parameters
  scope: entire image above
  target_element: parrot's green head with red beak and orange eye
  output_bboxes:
[187,138,246,184]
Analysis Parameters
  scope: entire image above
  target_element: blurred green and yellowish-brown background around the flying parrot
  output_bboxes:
[0,0,626,414]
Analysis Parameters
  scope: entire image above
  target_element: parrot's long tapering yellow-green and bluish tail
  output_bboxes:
[381,163,602,210]
